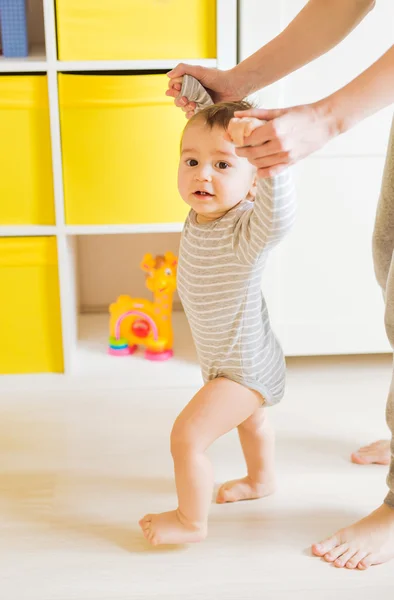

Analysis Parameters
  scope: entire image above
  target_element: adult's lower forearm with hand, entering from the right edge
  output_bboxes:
[231,46,394,177]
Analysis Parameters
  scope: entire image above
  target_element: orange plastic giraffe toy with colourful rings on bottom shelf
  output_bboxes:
[108,252,178,361]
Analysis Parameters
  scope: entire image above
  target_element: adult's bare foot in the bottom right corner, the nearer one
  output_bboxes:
[312,504,394,570]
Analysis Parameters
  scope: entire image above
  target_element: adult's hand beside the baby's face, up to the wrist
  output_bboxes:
[235,101,338,177]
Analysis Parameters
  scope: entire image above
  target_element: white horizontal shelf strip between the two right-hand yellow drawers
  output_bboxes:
[56,58,218,71]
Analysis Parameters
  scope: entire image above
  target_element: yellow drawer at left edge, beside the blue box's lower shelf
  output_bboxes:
[0,75,55,225]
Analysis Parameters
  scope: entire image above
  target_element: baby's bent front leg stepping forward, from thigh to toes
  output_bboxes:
[140,378,261,545]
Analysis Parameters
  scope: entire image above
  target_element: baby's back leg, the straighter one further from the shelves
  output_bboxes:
[216,408,275,504]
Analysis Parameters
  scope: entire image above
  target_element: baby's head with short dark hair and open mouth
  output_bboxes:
[178,101,256,222]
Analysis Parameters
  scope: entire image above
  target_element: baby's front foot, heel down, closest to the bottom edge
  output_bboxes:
[139,510,207,546]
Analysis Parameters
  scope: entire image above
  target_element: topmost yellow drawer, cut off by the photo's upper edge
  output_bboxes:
[56,0,216,60]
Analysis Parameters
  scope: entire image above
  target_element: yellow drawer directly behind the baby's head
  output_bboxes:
[59,75,187,225]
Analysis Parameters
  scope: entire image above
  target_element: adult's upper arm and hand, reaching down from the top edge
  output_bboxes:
[166,0,375,116]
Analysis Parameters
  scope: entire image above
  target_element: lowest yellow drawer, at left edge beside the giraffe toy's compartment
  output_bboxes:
[0,237,63,375]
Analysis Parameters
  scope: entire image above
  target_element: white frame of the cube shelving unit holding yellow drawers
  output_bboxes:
[0,0,237,386]
